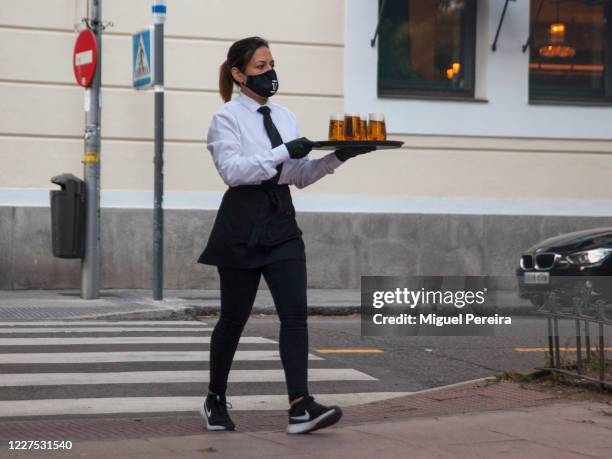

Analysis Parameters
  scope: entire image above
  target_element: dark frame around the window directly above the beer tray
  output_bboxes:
[376,0,480,102]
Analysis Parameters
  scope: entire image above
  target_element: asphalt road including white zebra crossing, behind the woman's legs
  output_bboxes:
[0,315,611,420]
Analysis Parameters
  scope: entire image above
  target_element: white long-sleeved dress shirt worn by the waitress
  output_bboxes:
[207,91,342,188]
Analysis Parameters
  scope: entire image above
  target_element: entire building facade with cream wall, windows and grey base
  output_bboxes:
[0,0,612,289]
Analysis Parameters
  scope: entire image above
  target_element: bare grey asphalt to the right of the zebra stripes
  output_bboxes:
[245,316,575,391]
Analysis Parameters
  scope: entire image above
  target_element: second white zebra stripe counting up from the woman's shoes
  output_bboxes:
[0,368,378,387]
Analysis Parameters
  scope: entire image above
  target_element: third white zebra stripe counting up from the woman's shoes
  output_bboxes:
[0,350,323,364]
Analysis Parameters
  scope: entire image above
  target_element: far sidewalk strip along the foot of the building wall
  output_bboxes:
[0,289,533,321]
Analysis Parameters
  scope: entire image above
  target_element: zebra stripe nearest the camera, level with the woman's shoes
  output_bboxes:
[0,392,412,417]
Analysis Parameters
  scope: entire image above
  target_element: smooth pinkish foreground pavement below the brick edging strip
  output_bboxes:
[0,402,612,459]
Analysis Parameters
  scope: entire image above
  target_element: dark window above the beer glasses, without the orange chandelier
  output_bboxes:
[378,0,476,98]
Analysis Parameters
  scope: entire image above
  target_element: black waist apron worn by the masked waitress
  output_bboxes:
[198,181,306,268]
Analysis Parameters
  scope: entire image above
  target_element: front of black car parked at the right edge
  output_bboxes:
[516,227,612,306]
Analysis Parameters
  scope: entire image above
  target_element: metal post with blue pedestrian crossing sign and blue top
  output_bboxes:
[132,0,166,300]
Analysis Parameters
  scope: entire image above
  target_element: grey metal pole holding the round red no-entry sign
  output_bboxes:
[81,0,103,300]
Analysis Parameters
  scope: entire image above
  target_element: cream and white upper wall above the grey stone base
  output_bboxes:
[0,0,612,210]
